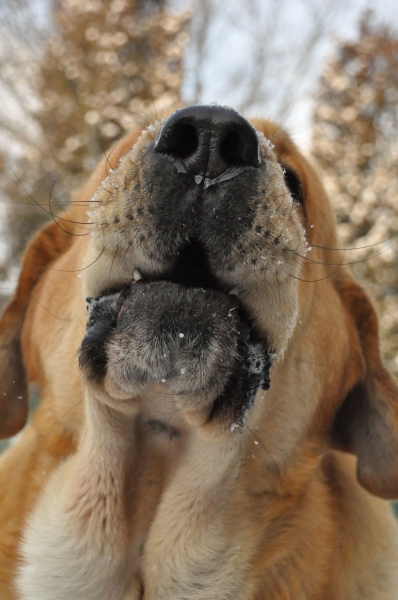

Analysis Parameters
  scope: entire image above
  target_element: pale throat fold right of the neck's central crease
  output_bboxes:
[143,427,247,600]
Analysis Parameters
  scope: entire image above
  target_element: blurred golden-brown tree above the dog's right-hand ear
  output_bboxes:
[313,12,398,375]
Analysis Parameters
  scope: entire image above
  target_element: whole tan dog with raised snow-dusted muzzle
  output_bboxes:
[0,105,398,600]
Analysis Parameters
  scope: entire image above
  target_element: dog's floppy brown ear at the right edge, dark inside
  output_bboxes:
[332,280,398,500]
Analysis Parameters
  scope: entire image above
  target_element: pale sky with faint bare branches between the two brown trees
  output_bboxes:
[183,0,351,122]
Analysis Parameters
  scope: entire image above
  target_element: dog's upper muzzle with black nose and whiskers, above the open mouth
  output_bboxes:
[86,106,306,353]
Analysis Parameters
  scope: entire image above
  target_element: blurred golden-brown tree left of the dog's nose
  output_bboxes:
[0,0,188,265]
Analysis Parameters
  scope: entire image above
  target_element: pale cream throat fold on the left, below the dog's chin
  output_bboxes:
[19,393,145,600]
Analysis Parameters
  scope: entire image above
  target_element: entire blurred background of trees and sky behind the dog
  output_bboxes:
[0,0,398,478]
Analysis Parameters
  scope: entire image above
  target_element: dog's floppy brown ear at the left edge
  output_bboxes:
[0,222,72,439]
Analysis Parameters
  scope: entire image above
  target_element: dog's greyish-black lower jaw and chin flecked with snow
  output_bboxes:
[80,281,270,424]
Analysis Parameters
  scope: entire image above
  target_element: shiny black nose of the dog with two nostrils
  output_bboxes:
[155,106,261,183]
